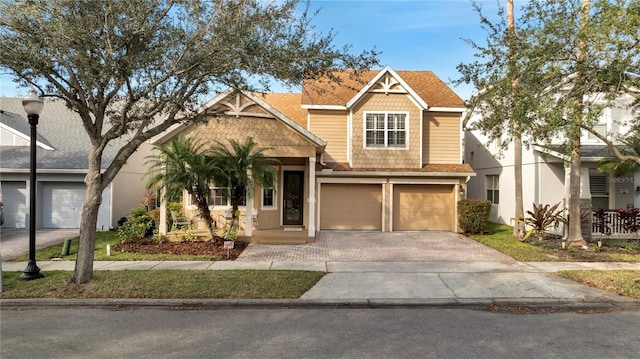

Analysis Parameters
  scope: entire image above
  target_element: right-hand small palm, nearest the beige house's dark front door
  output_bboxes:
[209,137,279,238]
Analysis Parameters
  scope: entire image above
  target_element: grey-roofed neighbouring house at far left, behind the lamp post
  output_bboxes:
[0,97,151,230]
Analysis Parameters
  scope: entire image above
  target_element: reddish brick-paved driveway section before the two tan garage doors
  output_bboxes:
[237,231,516,263]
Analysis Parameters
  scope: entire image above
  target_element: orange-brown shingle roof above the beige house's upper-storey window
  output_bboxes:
[302,67,465,108]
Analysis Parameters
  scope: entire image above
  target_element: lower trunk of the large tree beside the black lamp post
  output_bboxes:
[73,166,102,284]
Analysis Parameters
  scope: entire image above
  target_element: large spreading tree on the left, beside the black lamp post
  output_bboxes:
[0,0,377,283]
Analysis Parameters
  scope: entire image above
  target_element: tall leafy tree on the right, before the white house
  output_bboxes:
[459,0,640,245]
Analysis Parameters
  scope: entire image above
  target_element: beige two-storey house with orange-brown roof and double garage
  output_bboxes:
[159,67,475,240]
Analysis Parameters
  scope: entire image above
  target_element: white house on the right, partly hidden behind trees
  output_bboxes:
[464,96,640,225]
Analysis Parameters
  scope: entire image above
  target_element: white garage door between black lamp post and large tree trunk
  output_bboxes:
[42,182,85,228]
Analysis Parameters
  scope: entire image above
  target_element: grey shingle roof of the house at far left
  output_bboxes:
[0,97,128,173]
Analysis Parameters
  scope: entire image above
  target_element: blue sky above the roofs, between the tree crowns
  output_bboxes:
[0,0,504,99]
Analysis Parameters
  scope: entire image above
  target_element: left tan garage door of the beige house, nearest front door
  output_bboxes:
[320,183,382,231]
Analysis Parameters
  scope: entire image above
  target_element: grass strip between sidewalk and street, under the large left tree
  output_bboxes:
[0,270,325,299]
